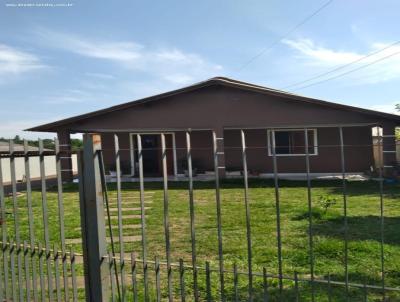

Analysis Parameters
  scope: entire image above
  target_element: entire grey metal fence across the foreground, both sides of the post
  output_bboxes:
[0,127,400,301]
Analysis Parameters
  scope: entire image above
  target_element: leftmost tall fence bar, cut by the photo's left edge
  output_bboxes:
[0,147,10,300]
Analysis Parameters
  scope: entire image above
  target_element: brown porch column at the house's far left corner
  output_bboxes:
[57,130,74,182]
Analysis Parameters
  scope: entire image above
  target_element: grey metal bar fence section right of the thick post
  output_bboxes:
[79,127,399,301]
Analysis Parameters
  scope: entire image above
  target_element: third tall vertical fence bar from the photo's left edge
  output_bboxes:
[24,140,39,301]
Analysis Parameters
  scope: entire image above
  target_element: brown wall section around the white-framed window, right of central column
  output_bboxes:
[224,127,374,173]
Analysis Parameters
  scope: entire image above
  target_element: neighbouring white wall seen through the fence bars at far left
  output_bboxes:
[1,154,78,183]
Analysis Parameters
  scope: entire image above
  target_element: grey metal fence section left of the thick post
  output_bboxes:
[0,140,82,301]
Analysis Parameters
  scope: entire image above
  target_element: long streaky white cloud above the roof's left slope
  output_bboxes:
[36,29,222,84]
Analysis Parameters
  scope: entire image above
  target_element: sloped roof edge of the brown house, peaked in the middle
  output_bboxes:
[26,77,400,132]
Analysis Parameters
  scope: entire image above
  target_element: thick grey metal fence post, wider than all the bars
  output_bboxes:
[79,134,110,302]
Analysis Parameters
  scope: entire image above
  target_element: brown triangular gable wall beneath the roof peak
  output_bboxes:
[68,86,394,132]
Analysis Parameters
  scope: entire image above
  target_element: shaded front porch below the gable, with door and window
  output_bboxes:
[59,124,397,182]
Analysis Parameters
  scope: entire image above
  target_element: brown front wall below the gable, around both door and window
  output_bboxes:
[102,127,374,174]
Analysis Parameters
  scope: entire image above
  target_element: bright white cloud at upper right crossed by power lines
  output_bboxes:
[283,39,400,85]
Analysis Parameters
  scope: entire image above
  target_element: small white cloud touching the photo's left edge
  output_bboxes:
[0,44,46,77]
